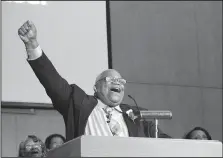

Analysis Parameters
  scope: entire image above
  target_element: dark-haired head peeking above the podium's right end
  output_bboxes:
[185,127,211,140]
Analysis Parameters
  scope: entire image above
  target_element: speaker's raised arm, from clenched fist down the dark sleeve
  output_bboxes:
[18,21,72,115]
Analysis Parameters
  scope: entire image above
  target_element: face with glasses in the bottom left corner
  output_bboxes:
[24,139,42,157]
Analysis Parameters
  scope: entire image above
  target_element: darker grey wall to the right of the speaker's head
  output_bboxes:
[110,1,222,141]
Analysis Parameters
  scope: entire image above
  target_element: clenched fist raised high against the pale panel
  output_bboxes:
[18,20,37,44]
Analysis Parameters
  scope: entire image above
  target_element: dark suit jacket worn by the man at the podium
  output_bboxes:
[28,52,169,141]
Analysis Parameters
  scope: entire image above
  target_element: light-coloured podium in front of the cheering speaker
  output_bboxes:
[47,136,222,158]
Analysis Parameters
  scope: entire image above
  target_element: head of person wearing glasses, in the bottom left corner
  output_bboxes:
[23,135,46,157]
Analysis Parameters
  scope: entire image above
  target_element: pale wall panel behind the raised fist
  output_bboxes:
[2,1,108,103]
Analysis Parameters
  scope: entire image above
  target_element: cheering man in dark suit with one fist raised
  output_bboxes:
[18,21,169,140]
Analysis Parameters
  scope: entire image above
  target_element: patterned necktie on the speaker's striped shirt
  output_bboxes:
[103,107,121,136]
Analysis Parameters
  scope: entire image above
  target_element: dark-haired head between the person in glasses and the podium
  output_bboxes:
[45,134,65,150]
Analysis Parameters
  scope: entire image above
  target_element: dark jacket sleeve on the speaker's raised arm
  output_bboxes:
[28,52,72,115]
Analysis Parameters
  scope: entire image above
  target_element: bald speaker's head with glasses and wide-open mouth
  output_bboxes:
[96,70,125,107]
